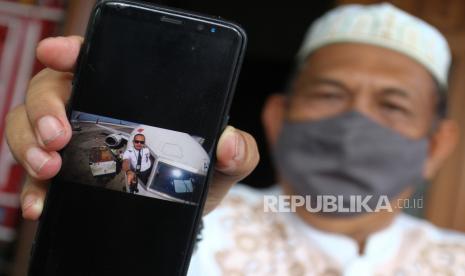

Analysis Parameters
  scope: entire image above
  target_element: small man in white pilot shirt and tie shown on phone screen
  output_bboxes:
[123,133,152,193]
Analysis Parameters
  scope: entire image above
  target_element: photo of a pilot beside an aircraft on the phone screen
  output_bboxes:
[59,111,210,204]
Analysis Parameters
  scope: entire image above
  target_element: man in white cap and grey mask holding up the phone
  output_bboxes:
[8,1,465,275]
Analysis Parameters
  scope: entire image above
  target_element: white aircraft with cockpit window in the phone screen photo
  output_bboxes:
[96,123,210,204]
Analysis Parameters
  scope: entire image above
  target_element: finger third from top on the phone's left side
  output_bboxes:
[6,105,61,180]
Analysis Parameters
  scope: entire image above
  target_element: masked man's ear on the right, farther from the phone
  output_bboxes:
[423,119,459,179]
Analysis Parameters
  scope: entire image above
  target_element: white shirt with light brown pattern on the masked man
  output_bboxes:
[188,185,465,276]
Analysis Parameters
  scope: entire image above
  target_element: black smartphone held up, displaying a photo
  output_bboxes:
[29,1,246,276]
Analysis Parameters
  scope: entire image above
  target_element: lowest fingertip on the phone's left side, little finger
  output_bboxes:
[21,176,48,220]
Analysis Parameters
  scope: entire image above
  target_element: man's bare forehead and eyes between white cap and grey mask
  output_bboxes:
[286,43,438,138]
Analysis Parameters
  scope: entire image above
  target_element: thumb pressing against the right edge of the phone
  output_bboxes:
[204,126,260,214]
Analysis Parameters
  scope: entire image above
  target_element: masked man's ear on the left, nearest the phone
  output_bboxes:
[262,94,286,147]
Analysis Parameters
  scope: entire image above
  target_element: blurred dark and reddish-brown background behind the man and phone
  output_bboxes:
[0,0,465,276]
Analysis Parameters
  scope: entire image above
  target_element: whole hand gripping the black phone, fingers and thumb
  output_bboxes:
[6,36,259,219]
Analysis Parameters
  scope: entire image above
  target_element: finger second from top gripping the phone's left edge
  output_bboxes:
[26,68,72,151]
